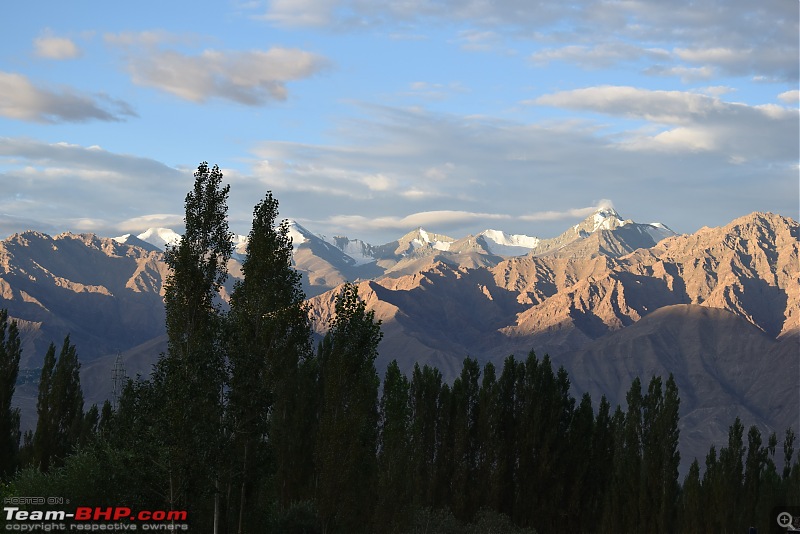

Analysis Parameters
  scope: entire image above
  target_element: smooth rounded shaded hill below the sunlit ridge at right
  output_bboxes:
[554,304,800,474]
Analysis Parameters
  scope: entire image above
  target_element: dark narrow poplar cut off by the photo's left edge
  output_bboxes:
[0,309,22,480]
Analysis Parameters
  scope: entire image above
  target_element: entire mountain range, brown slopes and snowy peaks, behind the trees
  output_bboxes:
[0,208,800,474]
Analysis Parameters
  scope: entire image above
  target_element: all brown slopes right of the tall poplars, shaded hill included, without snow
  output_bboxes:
[311,213,800,468]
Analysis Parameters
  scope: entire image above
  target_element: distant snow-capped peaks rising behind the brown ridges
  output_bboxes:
[114,208,676,297]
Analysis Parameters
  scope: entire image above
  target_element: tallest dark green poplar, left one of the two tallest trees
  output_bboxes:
[154,162,233,525]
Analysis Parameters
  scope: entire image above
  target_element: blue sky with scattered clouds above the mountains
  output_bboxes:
[0,0,800,244]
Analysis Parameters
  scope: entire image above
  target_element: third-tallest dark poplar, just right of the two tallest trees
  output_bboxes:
[317,284,382,532]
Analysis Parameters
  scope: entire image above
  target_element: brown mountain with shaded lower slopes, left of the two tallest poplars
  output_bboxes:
[0,232,167,367]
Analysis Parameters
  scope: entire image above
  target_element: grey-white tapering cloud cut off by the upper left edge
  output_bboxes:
[0,71,136,123]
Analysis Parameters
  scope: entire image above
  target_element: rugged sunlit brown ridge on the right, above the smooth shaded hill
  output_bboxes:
[311,213,800,378]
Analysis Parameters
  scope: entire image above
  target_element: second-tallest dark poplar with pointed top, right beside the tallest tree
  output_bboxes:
[227,192,315,531]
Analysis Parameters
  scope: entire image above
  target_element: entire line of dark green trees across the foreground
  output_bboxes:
[0,163,800,533]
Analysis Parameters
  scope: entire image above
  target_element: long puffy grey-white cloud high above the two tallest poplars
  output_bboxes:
[128,47,326,106]
